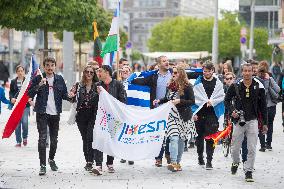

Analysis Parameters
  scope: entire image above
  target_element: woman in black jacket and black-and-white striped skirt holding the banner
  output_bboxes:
[153,66,197,172]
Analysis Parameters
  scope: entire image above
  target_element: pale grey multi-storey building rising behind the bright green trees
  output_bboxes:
[100,0,214,52]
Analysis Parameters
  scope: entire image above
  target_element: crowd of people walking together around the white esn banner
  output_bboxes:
[3,56,282,181]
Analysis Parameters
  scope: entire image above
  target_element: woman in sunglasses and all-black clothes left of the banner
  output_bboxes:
[69,65,99,171]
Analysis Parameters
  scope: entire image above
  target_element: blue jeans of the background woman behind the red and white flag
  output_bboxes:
[15,107,30,144]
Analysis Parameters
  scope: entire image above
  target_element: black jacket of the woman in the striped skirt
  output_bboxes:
[160,84,195,121]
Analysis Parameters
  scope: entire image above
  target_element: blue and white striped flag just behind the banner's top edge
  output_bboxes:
[124,71,158,108]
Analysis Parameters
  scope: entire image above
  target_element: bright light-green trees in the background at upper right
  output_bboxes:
[148,12,272,59]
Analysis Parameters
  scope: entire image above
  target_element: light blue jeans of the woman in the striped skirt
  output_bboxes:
[169,136,184,163]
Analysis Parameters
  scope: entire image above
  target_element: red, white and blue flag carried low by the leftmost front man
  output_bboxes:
[2,56,40,139]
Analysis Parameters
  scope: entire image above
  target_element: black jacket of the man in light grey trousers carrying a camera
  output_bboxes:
[225,78,267,125]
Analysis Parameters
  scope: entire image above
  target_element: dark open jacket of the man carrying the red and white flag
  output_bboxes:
[28,73,70,114]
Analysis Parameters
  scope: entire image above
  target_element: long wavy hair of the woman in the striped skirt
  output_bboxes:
[169,66,190,95]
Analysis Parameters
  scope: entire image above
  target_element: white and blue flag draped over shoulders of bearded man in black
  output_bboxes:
[191,76,225,131]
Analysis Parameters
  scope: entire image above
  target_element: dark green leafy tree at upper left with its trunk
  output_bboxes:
[0,0,107,55]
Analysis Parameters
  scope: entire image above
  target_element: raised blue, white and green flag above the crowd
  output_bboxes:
[101,1,120,66]
